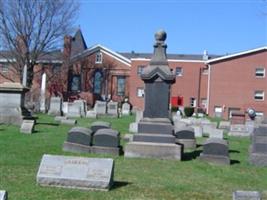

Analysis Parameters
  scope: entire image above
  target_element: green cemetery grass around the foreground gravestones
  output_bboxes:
[0,114,267,200]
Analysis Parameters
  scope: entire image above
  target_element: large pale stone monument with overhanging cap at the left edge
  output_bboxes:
[0,82,31,126]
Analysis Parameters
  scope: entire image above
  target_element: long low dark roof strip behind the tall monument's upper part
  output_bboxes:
[119,52,221,60]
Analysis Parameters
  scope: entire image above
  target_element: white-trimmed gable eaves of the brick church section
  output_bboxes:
[71,44,131,67]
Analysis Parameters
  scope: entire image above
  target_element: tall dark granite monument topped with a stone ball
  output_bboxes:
[125,30,181,160]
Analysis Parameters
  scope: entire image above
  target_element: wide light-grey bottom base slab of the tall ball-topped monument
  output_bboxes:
[124,142,182,160]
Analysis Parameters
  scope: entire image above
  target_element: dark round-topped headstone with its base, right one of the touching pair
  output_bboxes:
[91,129,121,155]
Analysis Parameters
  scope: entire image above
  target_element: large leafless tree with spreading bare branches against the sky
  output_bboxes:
[0,0,79,86]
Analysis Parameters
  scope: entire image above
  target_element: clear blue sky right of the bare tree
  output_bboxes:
[77,0,267,54]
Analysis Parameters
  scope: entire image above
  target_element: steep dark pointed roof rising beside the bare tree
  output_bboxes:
[71,29,87,57]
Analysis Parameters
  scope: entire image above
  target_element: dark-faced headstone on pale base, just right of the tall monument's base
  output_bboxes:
[174,127,196,149]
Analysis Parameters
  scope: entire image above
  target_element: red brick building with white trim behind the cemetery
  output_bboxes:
[0,30,267,119]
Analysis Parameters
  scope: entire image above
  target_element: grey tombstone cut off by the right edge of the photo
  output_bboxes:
[249,127,267,166]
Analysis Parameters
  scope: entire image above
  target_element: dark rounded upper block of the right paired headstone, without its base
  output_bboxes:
[93,129,120,147]
